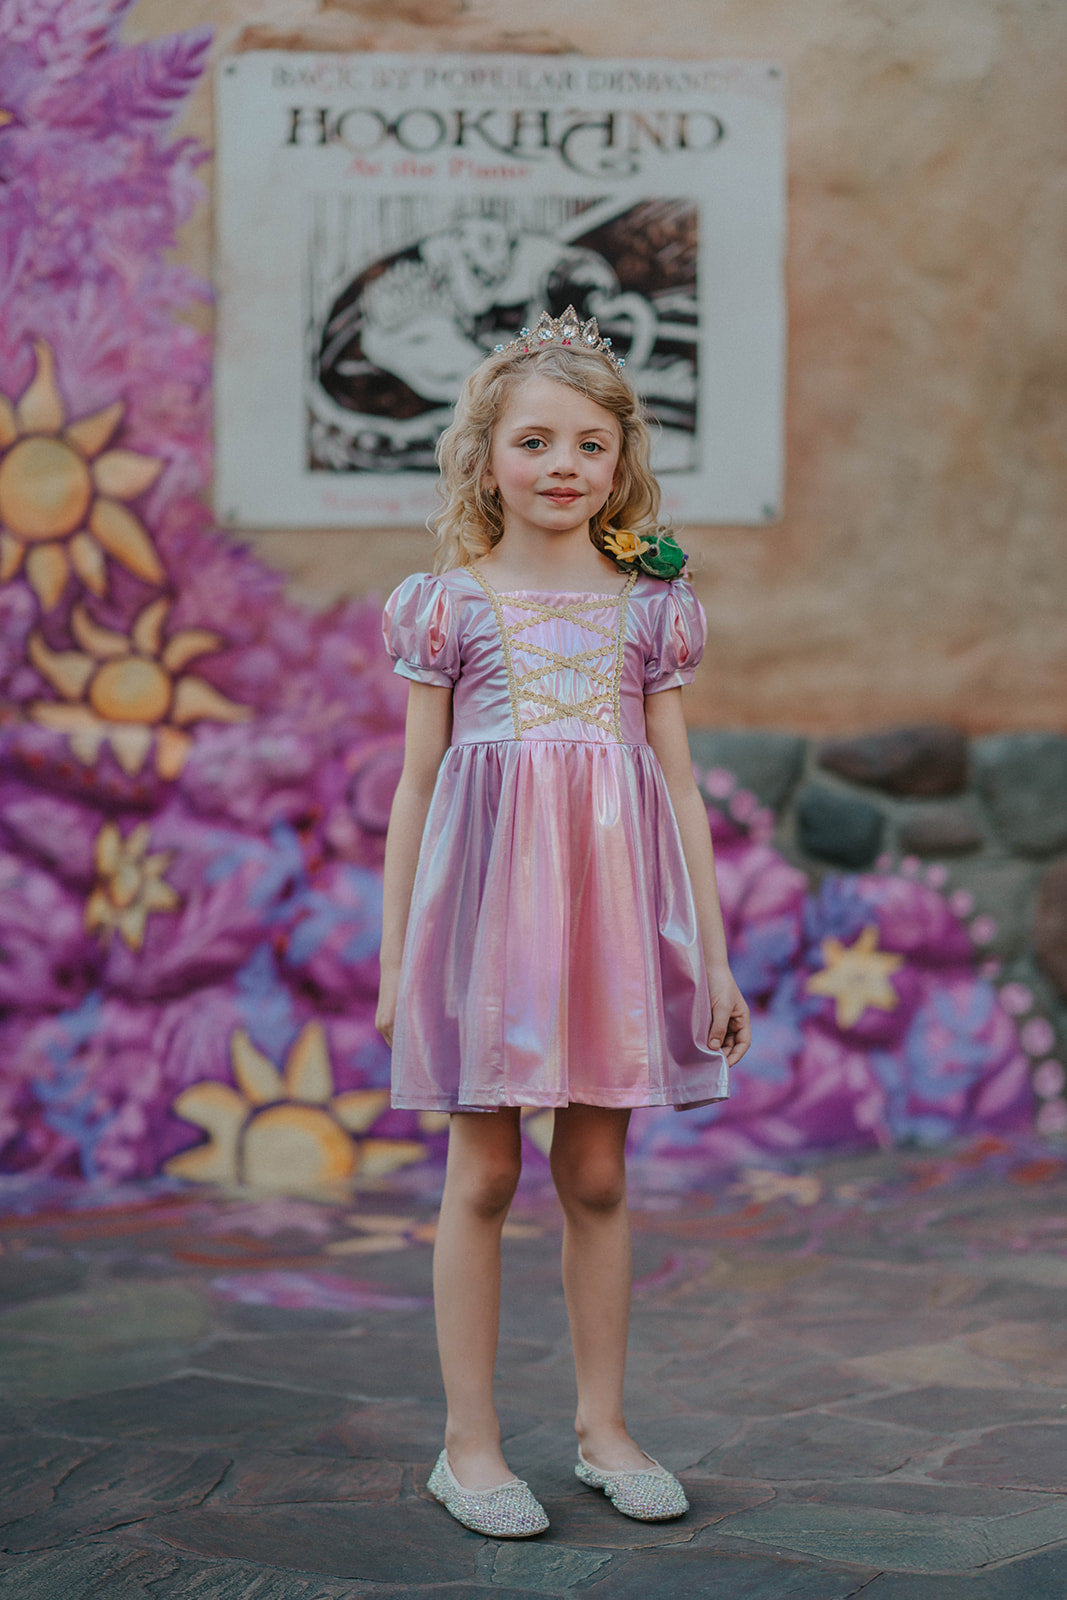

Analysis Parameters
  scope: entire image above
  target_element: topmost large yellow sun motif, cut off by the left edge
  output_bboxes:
[0,341,166,611]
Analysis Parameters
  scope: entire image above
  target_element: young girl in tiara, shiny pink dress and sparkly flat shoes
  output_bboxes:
[378,309,749,1536]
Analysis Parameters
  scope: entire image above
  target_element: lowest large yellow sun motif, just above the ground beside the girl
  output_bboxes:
[165,1022,426,1194]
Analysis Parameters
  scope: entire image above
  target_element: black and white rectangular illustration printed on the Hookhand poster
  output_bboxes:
[306,195,699,472]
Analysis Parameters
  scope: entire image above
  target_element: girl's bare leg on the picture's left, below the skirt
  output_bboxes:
[434,1106,522,1490]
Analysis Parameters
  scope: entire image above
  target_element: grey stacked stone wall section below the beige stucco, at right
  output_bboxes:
[689,725,1067,1133]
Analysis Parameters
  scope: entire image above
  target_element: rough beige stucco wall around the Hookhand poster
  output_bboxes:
[126,0,1067,733]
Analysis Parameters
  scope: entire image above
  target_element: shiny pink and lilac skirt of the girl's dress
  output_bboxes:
[394,741,726,1110]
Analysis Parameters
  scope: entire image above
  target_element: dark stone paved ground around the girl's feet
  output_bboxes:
[0,1141,1067,1600]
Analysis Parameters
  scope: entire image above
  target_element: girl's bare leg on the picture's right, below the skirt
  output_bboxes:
[552,1106,648,1472]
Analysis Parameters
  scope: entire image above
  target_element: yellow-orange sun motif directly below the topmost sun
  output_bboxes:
[27,597,251,778]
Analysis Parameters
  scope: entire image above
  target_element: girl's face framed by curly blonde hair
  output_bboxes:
[486,376,622,534]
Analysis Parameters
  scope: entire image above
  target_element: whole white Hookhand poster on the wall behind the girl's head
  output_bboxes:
[216,53,784,526]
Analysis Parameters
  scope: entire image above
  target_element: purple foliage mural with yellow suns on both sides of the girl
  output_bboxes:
[0,0,1030,1190]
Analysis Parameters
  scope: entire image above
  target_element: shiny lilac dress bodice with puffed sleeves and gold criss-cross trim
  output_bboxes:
[386,566,704,744]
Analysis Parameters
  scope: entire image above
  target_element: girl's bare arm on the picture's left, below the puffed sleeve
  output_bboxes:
[374,683,453,1045]
